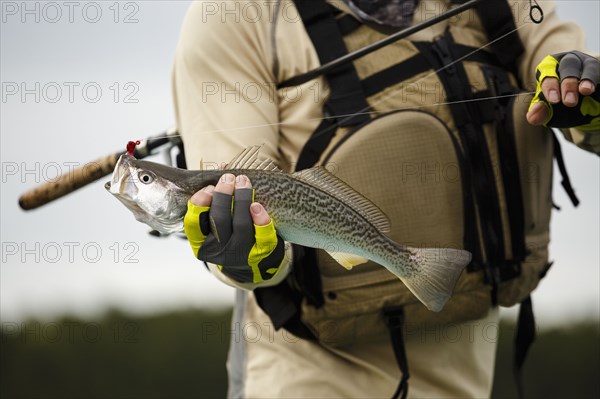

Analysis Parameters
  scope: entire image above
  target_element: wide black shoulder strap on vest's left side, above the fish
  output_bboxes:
[294,0,369,170]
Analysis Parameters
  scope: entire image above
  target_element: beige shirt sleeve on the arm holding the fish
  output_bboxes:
[172,1,292,289]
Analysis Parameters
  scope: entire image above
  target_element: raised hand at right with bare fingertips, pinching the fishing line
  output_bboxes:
[527,51,600,130]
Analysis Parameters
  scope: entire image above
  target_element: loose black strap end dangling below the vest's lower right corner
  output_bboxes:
[513,296,535,398]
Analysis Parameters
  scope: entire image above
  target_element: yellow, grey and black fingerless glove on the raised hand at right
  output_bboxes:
[529,51,600,130]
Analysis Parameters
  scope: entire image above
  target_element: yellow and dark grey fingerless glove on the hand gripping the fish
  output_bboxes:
[183,188,285,283]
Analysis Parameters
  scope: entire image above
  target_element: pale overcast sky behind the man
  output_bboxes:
[0,0,600,325]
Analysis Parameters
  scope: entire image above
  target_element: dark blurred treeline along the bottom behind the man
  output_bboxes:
[0,311,600,399]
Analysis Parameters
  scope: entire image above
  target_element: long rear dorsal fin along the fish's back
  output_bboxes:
[294,166,390,233]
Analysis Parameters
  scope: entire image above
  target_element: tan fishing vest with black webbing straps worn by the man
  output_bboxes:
[255,0,577,366]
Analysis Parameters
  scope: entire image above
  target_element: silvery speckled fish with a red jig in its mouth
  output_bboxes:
[105,146,471,312]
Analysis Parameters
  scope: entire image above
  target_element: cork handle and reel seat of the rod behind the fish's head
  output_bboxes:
[19,128,182,211]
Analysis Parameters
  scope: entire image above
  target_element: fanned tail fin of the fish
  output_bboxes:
[399,248,471,312]
